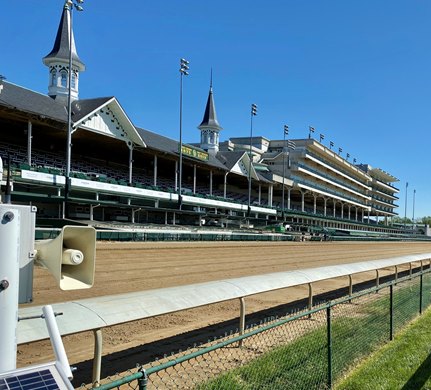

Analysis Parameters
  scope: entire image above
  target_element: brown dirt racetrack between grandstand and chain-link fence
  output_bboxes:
[18,242,431,385]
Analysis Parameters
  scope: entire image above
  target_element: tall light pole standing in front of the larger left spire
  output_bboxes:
[64,0,84,218]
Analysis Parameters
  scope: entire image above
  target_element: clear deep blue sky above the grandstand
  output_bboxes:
[0,0,431,218]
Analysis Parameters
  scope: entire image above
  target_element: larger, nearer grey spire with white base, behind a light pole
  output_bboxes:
[43,4,85,100]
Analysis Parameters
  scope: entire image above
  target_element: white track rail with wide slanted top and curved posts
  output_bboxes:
[17,252,431,383]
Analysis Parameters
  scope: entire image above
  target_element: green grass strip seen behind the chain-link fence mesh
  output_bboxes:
[197,275,431,390]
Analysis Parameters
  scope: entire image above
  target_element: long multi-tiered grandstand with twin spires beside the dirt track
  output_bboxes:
[0,5,426,238]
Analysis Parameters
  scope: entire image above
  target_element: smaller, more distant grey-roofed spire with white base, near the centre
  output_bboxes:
[198,69,223,154]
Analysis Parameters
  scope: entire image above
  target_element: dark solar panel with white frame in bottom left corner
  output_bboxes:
[0,362,73,390]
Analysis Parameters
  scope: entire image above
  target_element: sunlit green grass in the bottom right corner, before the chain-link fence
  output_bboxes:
[336,310,431,390]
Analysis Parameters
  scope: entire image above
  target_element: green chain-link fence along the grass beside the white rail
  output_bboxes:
[86,269,431,390]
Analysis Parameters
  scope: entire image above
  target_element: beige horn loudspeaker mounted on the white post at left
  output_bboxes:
[35,226,96,290]
